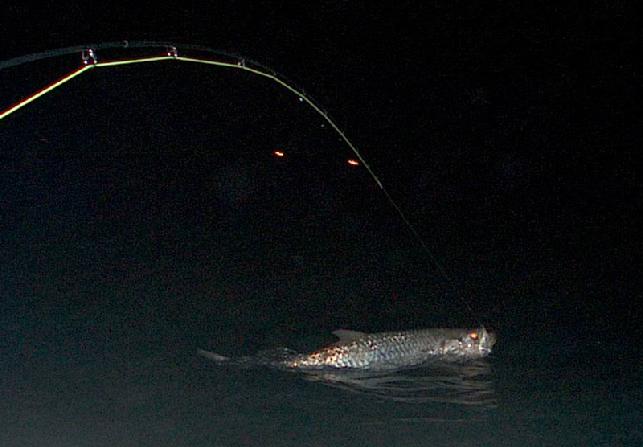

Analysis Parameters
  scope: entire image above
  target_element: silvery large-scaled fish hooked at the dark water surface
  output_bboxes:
[197,327,496,371]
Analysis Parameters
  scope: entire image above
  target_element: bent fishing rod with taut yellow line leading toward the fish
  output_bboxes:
[0,41,475,322]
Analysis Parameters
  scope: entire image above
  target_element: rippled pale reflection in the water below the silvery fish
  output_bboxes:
[302,360,496,407]
